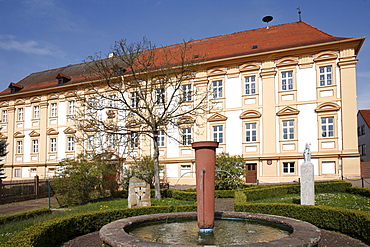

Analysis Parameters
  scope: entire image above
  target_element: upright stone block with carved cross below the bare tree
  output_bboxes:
[128,177,151,208]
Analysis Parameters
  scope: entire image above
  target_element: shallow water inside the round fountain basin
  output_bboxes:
[126,218,291,245]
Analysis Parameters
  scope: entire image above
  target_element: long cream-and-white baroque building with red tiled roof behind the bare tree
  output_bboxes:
[0,22,365,184]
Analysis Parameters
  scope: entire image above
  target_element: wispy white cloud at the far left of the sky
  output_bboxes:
[0,35,61,56]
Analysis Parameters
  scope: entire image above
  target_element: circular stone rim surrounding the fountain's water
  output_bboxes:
[99,212,321,247]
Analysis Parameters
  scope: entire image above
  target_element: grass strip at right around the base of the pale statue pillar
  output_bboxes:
[248,193,370,211]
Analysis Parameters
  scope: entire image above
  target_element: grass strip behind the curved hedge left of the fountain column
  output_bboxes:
[0,198,194,243]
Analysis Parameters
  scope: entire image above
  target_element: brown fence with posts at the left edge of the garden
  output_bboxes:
[0,176,50,204]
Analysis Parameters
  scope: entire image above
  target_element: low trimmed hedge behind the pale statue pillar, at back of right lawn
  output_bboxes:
[241,180,352,201]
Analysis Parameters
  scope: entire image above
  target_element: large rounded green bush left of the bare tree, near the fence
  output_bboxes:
[52,155,119,206]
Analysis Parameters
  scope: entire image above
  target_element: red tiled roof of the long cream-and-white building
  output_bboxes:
[0,22,364,95]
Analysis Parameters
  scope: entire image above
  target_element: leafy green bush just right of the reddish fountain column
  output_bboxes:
[216,153,246,190]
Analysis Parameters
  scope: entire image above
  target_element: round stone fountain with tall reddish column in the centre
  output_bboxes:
[99,141,321,247]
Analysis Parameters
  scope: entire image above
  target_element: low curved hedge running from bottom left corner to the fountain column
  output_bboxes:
[0,205,196,247]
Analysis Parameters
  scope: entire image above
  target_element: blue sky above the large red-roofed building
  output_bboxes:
[0,0,370,109]
